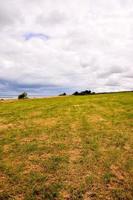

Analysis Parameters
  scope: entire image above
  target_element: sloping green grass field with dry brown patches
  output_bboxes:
[0,92,133,200]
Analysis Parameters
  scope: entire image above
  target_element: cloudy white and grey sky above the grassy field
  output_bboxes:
[0,0,133,96]
